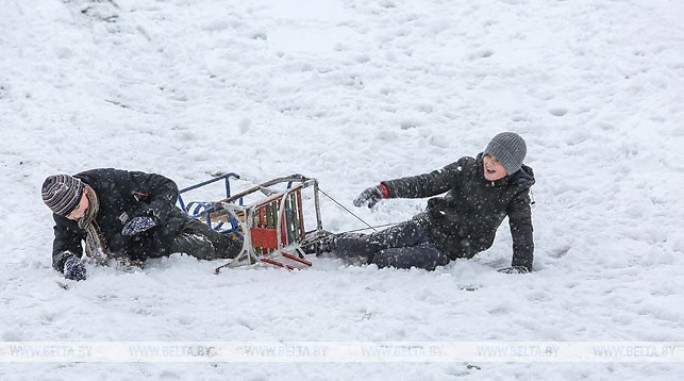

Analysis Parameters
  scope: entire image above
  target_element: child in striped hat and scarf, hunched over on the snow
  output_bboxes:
[42,168,242,280]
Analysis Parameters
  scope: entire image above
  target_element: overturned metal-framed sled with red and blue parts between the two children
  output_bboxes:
[179,174,322,273]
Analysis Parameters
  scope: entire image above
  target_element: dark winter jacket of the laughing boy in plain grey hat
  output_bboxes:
[383,154,534,270]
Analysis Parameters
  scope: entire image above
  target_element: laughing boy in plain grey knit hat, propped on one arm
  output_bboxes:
[302,132,534,273]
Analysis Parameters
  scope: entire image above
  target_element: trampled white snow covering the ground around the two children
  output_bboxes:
[0,0,684,380]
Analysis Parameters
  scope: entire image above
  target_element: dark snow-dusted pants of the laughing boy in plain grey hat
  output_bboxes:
[333,221,449,270]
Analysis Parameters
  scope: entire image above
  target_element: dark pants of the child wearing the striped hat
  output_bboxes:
[169,219,242,260]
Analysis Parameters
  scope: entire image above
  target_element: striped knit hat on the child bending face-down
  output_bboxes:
[42,175,85,217]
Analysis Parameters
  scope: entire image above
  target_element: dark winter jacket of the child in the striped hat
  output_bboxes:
[52,168,188,271]
